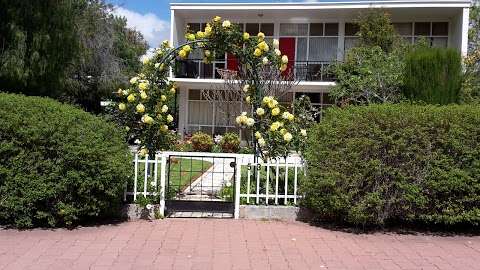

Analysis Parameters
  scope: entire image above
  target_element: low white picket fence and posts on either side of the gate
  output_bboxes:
[124,151,305,218]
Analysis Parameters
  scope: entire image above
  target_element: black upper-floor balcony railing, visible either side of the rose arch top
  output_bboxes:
[174,59,335,82]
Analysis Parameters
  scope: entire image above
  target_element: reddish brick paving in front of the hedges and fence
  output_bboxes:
[0,219,480,270]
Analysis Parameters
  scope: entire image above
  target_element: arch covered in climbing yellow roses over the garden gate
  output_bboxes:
[118,16,306,160]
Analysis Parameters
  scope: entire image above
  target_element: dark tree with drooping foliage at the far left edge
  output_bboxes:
[0,0,80,96]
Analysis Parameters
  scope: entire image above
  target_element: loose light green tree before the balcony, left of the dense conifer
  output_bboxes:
[330,10,406,104]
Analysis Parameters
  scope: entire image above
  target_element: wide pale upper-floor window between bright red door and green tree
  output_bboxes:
[308,37,338,61]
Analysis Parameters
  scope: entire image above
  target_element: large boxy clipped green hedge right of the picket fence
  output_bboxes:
[302,104,480,226]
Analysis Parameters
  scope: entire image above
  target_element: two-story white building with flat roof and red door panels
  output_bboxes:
[170,0,470,137]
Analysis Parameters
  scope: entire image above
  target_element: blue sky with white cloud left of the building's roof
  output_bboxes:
[106,0,364,47]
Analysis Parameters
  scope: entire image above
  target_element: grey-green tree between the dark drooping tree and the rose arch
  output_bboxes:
[62,0,147,113]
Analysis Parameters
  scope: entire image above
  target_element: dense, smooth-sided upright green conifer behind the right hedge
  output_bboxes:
[404,47,463,104]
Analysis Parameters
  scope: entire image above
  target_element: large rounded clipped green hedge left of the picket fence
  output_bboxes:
[0,93,131,228]
